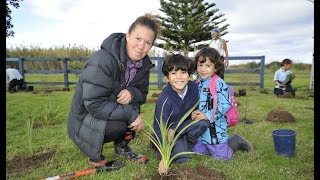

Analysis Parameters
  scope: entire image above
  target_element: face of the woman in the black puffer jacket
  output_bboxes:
[126,25,155,61]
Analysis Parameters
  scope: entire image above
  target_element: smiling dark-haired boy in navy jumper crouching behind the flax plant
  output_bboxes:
[151,54,209,174]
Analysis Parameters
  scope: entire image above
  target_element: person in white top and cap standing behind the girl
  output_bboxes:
[209,28,229,79]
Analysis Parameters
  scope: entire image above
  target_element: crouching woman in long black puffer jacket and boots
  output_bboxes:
[68,14,159,166]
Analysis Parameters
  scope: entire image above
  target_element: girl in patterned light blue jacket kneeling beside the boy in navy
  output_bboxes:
[191,47,253,160]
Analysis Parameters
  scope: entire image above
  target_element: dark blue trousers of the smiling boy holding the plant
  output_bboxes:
[152,120,210,163]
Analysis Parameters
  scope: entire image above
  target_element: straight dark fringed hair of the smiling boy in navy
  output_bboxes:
[162,54,194,77]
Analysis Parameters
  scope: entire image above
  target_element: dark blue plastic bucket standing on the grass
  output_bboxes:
[272,129,296,157]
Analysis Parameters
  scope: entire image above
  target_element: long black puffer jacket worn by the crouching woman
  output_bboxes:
[68,33,154,159]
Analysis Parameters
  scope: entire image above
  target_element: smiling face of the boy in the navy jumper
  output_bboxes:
[167,69,189,95]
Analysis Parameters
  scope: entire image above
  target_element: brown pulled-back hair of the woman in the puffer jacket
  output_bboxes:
[129,13,159,42]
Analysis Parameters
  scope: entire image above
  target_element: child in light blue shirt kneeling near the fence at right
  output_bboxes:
[273,59,294,96]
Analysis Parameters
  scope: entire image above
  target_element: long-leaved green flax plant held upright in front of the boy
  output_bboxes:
[145,99,199,174]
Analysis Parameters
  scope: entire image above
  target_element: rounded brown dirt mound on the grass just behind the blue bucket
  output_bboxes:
[266,108,294,122]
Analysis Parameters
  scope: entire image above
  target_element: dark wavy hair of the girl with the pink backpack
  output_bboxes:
[194,47,224,77]
